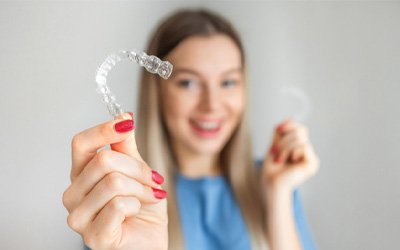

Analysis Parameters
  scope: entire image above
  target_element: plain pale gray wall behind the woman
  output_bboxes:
[0,1,400,250]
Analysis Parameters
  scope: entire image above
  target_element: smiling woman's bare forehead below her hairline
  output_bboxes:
[168,34,242,75]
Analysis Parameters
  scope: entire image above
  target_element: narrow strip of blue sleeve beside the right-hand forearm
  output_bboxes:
[293,189,316,250]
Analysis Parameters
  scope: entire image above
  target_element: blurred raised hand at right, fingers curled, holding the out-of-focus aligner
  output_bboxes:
[263,119,319,190]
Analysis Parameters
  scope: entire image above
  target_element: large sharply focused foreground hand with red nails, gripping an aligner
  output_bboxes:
[63,114,168,250]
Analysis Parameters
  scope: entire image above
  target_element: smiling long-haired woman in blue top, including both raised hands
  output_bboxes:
[63,10,318,250]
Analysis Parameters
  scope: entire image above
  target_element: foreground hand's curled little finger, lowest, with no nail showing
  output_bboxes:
[85,196,141,249]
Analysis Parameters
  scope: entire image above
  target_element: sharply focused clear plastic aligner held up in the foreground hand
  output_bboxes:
[96,50,173,118]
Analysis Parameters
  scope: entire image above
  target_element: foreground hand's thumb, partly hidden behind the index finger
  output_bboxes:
[111,112,143,161]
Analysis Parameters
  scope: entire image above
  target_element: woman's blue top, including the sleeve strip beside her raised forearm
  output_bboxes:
[176,174,315,250]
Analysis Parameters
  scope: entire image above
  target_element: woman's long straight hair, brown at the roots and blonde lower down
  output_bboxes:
[135,10,267,250]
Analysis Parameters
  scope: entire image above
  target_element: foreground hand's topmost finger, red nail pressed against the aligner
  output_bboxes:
[71,114,133,180]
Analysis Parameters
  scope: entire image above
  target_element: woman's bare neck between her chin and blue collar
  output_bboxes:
[175,144,221,178]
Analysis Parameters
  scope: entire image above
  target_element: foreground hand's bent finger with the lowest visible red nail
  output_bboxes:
[69,172,166,232]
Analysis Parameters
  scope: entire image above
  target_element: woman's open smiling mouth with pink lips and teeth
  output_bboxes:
[190,120,222,139]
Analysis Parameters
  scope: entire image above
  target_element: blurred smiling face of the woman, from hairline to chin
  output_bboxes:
[161,35,245,154]
